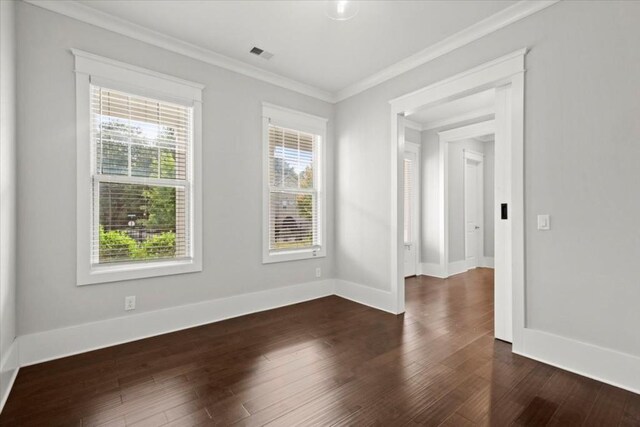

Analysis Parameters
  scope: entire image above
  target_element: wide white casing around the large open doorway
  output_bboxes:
[389,48,531,353]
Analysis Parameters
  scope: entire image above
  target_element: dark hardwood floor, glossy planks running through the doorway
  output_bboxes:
[0,269,640,427]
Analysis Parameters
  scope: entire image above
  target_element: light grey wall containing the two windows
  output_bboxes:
[13,2,335,335]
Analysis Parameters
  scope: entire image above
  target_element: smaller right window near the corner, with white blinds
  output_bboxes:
[265,104,324,262]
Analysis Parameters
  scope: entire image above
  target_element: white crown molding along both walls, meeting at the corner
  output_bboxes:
[23,0,559,103]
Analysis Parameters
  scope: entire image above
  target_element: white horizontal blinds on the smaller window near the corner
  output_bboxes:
[268,125,320,252]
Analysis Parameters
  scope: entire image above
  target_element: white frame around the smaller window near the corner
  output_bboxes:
[262,102,328,264]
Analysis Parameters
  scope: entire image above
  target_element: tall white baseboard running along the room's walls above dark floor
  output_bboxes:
[10,280,640,410]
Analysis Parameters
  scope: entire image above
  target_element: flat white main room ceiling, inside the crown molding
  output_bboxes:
[75,0,516,93]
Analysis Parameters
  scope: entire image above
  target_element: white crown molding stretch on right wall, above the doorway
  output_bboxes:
[335,0,560,102]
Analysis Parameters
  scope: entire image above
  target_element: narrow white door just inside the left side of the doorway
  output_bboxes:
[403,148,419,277]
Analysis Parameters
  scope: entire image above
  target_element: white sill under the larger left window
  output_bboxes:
[78,259,202,286]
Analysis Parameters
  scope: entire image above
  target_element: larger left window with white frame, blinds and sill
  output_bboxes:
[71,49,204,286]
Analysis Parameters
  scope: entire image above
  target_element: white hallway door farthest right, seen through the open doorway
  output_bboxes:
[464,158,482,268]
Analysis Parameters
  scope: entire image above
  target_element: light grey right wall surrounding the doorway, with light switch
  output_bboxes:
[336,1,640,355]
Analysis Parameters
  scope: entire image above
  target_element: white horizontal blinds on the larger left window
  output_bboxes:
[90,85,193,264]
